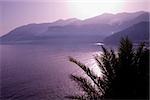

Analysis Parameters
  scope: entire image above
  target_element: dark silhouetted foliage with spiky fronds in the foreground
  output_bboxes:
[66,38,149,100]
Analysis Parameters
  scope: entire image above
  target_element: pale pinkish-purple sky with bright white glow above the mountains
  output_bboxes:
[0,0,150,36]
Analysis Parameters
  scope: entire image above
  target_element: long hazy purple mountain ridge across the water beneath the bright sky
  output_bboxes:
[0,11,149,43]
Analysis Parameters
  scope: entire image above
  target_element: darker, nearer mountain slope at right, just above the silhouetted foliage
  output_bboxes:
[104,22,149,44]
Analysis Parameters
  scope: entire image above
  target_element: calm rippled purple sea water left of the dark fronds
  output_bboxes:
[0,44,100,100]
